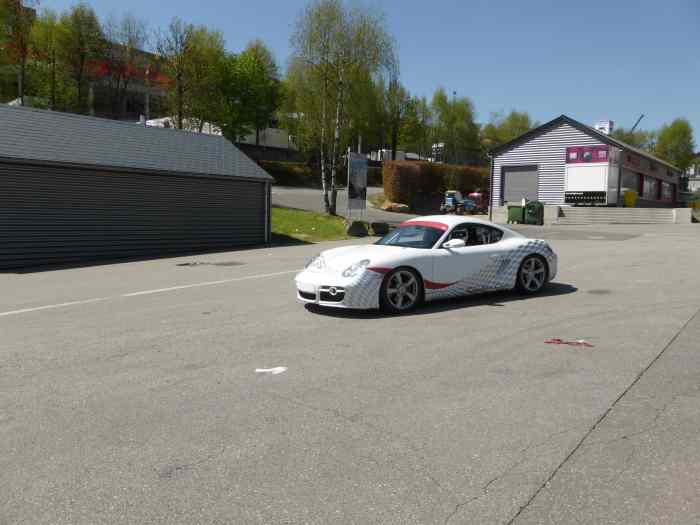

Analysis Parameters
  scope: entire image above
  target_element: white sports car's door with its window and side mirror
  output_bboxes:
[426,223,505,295]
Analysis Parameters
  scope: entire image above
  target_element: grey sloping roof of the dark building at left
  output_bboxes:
[0,104,272,180]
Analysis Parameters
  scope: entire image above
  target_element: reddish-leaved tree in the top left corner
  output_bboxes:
[0,0,36,105]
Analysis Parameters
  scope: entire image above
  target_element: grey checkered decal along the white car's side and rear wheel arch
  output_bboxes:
[425,240,556,300]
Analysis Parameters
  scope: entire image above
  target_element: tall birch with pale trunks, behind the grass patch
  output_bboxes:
[291,0,395,214]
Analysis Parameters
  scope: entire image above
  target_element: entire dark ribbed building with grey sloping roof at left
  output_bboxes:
[0,104,273,268]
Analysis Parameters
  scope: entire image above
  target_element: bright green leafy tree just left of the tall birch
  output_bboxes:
[239,40,280,145]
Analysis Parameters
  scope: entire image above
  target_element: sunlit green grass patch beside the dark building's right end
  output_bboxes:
[272,207,349,242]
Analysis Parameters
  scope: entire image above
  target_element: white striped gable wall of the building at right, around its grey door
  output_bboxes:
[492,123,603,206]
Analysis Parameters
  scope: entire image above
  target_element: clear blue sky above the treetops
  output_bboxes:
[41,0,700,137]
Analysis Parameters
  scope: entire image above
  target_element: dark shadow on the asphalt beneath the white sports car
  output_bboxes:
[305,282,578,319]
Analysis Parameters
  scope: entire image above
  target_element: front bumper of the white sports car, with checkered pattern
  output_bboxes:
[294,270,383,310]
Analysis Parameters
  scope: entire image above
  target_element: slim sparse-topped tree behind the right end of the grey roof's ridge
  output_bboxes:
[156,17,194,129]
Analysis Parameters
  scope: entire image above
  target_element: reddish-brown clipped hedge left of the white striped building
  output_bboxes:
[384,161,489,206]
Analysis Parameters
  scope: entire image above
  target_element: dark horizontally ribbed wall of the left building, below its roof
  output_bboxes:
[0,162,267,268]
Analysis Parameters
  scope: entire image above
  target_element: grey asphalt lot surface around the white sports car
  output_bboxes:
[0,225,700,524]
